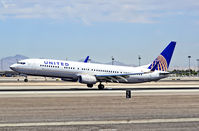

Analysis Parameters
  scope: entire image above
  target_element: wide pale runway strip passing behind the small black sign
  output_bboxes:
[0,89,199,98]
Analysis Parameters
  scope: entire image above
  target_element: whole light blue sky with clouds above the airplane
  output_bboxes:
[0,0,199,67]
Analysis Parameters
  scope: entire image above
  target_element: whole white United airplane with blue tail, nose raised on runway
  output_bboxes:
[10,41,176,90]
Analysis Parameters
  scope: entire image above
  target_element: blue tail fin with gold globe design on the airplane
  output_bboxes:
[148,41,176,71]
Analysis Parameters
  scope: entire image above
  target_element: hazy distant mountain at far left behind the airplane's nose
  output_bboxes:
[0,55,28,71]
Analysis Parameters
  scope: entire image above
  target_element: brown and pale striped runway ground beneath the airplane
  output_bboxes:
[0,83,199,131]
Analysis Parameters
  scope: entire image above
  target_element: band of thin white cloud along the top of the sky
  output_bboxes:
[0,0,199,24]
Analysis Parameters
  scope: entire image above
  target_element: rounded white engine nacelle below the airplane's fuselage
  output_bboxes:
[79,75,97,84]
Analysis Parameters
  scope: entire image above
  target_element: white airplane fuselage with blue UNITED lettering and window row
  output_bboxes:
[10,59,168,83]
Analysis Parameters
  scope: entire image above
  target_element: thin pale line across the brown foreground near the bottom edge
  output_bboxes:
[0,118,199,127]
